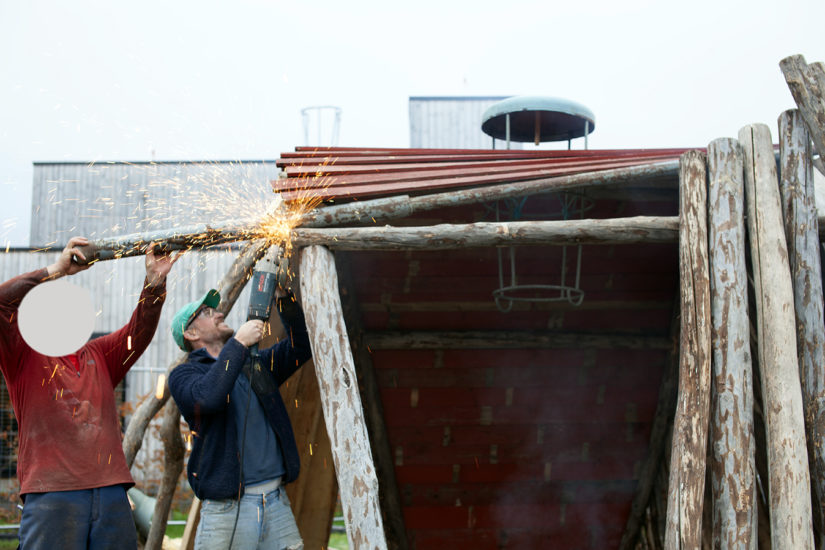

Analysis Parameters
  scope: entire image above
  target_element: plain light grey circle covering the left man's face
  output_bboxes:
[17,281,95,357]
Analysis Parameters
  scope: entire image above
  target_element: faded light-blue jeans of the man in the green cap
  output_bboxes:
[195,487,304,550]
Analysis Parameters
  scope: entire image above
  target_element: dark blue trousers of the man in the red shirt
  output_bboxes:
[19,485,137,550]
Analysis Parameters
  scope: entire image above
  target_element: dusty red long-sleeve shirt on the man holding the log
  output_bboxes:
[0,269,166,495]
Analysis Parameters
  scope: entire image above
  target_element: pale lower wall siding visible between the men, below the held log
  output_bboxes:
[0,251,249,480]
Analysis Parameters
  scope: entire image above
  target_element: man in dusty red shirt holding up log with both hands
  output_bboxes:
[0,237,177,550]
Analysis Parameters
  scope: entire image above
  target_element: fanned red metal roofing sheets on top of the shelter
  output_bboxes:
[272,147,687,201]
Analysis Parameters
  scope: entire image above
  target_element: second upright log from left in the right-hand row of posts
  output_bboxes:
[708,138,757,550]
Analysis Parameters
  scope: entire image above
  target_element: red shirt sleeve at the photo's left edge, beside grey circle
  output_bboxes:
[0,268,49,380]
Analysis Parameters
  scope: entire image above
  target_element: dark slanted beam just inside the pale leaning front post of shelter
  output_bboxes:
[335,256,409,550]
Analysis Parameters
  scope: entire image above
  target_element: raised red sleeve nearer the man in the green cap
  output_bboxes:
[89,281,166,387]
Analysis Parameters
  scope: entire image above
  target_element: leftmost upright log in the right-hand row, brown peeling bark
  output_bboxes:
[665,151,711,550]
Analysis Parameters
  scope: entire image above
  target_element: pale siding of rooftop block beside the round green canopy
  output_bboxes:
[410,96,522,149]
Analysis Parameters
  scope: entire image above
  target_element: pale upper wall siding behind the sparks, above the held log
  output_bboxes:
[29,161,278,247]
